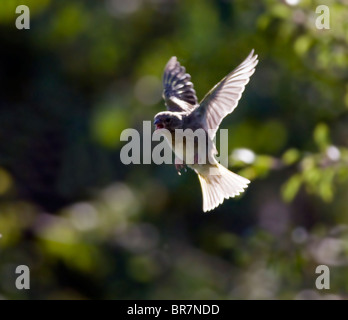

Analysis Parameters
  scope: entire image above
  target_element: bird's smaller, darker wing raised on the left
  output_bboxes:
[163,57,198,112]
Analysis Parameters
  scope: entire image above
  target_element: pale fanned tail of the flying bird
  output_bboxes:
[197,164,250,212]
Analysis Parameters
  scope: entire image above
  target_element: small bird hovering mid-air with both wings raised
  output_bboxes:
[154,50,258,212]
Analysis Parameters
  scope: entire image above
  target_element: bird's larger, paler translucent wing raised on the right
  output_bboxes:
[194,50,258,139]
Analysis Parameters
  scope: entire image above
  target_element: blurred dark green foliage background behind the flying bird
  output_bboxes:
[0,0,348,299]
